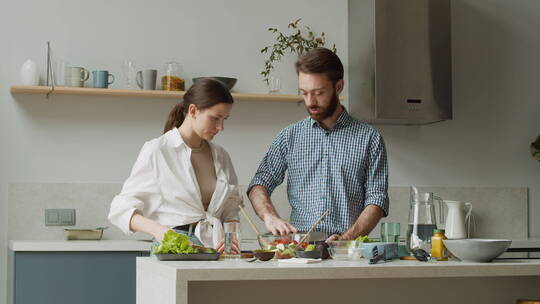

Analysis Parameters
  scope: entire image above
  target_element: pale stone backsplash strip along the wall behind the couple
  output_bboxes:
[8,183,528,240]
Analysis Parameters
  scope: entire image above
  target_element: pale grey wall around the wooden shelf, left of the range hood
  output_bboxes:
[0,0,347,303]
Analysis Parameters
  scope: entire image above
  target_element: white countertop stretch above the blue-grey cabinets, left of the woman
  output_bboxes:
[9,240,152,252]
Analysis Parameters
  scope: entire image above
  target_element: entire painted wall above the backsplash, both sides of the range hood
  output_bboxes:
[0,0,540,303]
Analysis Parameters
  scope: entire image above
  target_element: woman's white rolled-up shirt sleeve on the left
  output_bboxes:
[108,143,162,234]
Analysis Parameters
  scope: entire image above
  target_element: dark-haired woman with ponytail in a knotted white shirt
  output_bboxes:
[109,78,242,253]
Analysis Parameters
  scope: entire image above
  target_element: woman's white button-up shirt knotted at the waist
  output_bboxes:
[109,128,242,247]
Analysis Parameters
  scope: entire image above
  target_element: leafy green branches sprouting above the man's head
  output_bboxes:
[261,18,337,84]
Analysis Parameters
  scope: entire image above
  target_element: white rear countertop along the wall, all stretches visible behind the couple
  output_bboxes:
[9,239,540,251]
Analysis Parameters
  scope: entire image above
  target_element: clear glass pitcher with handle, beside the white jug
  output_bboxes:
[407,186,444,252]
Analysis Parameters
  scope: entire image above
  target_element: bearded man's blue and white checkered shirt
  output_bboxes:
[248,110,389,234]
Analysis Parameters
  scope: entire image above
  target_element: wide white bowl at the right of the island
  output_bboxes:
[443,239,512,262]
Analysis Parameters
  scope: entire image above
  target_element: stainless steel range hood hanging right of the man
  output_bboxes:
[347,0,452,125]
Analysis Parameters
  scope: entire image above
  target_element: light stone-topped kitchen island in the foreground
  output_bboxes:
[136,257,540,304]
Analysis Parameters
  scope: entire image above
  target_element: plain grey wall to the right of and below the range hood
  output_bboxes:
[378,0,540,238]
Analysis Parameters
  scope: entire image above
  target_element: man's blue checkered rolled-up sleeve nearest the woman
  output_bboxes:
[246,129,287,195]
